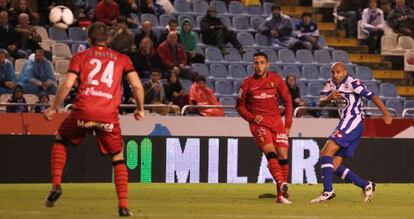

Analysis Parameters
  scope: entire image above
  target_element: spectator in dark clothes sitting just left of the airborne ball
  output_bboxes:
[15,13,42,57]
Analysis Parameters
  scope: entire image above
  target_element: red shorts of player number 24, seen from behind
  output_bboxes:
[58,113,124,155]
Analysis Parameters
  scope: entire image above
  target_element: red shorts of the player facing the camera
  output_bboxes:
[250,124,289,149]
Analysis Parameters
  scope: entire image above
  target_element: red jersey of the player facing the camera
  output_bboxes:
[236,72,292,133]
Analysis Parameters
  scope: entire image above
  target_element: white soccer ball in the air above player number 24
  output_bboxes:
[49,5,74,29]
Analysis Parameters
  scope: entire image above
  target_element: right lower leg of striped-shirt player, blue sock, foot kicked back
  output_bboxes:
[335,165,375,203]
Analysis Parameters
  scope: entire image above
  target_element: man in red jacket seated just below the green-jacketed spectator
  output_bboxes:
[157,32,192,80]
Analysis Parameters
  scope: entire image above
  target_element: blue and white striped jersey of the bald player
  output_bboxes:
[321,75,374,134]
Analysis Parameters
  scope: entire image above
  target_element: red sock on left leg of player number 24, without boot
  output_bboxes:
[50,142,66,187]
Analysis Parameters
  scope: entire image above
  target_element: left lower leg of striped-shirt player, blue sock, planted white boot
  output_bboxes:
[311,156,335,203]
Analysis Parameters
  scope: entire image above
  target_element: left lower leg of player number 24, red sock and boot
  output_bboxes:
[45,140,66,207]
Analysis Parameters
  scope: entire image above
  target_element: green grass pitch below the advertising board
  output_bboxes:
[0,183,414,219]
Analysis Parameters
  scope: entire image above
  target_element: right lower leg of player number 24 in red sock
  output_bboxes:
[112,160,132,217]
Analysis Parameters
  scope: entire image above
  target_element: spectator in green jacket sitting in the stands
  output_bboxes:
[179,19,204,65]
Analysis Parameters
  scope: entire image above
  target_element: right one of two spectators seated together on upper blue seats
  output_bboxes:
[294,12,322,49]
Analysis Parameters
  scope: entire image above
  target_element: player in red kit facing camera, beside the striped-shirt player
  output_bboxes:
[236,52,292,204]
